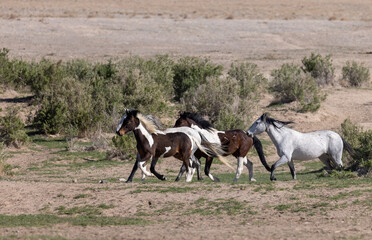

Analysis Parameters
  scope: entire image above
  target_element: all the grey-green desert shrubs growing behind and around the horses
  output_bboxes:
[0,49,370,172]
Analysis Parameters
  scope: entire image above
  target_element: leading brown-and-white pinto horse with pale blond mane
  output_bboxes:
[116,110,228,182]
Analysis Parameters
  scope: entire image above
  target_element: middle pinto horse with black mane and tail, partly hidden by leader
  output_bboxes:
[174,112,270,182]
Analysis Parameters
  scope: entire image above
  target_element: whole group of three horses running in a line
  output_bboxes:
[116,110,353,182]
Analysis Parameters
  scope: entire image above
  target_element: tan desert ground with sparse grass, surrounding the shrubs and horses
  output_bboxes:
[0,0,372,239]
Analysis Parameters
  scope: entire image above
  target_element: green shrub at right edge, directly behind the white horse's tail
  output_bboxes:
[341,119,372,172]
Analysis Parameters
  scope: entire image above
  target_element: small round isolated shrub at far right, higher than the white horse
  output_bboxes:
[342,61,370,87]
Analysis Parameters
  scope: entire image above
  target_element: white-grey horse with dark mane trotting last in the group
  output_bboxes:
[247,113,354,181]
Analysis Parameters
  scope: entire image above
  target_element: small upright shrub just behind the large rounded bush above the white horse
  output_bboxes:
[302,53,335,86]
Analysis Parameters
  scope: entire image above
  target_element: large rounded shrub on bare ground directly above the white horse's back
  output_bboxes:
[269,64,325,112]
